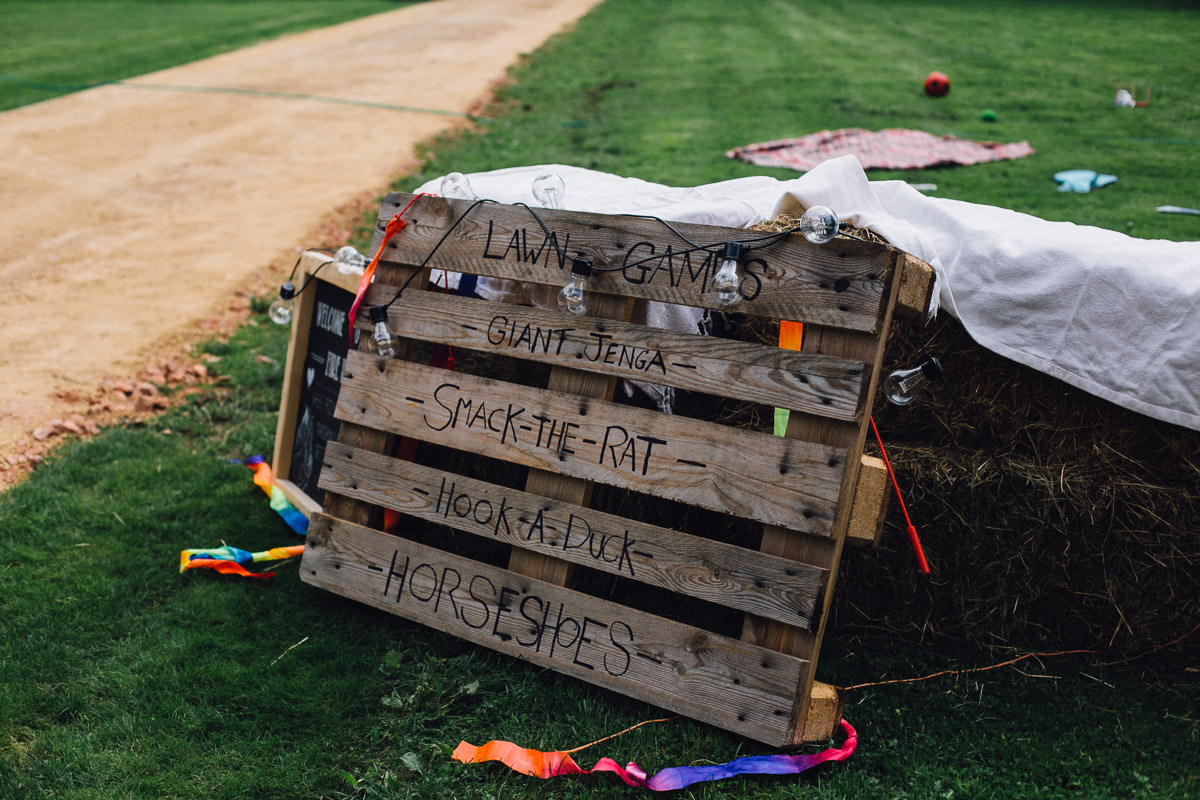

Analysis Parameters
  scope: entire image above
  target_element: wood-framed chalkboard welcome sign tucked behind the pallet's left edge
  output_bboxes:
[271,253,361,515]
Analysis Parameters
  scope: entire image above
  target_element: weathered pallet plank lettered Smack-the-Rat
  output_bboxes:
[336,353,850,535]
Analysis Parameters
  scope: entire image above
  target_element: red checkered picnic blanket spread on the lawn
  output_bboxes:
[725,128,1033,173]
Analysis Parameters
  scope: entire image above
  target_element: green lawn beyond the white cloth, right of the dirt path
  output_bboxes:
[401,0,1200,240]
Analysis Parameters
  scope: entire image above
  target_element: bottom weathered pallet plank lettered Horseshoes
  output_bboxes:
[301,515,808,746]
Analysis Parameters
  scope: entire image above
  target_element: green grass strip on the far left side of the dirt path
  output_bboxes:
[0,0,402,110]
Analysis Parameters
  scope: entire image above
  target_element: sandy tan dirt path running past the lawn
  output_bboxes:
[0,0,599,483]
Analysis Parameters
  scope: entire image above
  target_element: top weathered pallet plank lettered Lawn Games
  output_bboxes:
[374,194,892,331]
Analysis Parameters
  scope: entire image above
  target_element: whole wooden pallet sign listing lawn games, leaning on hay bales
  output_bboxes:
[301,194,926,746]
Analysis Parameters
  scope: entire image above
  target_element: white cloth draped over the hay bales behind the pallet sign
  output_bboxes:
[416,156,1200,429]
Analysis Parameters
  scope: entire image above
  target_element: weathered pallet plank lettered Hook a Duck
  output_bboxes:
[320,444,827,627]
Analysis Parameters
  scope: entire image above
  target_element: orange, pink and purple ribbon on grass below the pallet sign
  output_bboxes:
[454,720,858,792]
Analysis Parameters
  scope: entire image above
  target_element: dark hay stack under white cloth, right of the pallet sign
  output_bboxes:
[836,314,1200,655]
